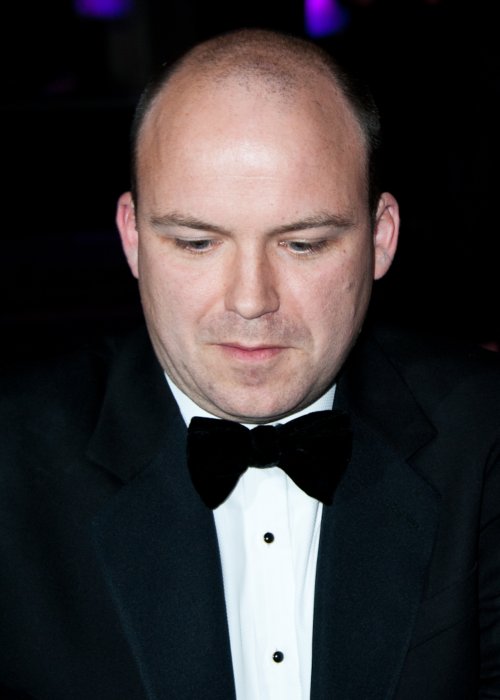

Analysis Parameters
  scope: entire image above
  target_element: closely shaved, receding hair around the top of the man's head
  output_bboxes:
[131,30,380,213]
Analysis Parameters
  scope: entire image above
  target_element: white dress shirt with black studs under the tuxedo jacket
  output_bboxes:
[167,377,335,700]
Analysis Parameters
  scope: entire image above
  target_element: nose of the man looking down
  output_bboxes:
[225,245,279,320]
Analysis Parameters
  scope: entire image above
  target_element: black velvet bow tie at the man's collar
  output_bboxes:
[187,411,352,508]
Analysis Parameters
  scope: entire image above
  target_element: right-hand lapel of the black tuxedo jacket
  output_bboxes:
[311,328,439,700]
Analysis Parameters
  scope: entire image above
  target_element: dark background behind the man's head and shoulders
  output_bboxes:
[0,0,500,362]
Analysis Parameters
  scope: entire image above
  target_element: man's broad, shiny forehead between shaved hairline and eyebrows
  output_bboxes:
[137,73,366,205]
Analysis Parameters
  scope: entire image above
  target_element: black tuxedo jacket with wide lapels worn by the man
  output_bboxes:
[0,332,500,700]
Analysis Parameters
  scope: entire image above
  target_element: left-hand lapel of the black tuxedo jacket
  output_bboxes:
[89,332,234,700]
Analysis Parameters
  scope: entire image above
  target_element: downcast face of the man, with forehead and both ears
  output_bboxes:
[117,72,397,422]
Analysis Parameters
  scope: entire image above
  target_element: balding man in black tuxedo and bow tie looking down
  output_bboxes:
[0,31,500,700]
